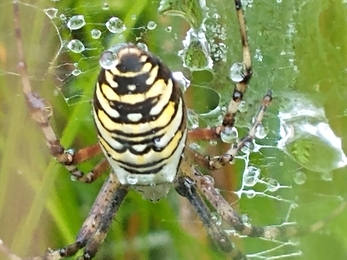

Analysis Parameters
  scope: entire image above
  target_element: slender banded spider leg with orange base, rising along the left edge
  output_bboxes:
[13,1,108,182]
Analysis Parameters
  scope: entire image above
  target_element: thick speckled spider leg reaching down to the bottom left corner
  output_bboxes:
[0,173,128,260]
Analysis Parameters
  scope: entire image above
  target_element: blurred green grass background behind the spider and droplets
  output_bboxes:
[0,0,347,260]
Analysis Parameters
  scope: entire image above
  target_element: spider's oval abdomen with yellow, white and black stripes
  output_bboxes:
[94,45,186,193]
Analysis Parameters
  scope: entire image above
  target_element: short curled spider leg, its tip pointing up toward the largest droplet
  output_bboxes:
[186,91,272,170]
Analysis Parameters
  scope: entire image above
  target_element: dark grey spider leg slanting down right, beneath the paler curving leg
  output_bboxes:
[175,167,247,260]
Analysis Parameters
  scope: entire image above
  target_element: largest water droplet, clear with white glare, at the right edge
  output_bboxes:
[277,97,347,173]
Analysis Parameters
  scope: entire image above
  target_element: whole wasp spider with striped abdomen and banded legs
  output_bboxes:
[0,0,345,260]
